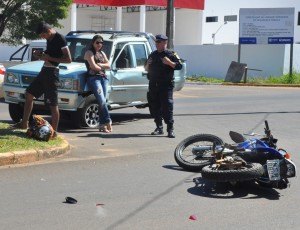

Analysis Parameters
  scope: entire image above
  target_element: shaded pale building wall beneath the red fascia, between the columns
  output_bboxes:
[57,7,203,45]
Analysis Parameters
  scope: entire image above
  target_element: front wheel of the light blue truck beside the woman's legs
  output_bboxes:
[72,98,99,128]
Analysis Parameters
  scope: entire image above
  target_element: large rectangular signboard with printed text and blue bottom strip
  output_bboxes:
[239,8,295,44]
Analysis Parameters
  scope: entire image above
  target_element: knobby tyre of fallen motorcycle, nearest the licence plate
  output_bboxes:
[201,163,264,182]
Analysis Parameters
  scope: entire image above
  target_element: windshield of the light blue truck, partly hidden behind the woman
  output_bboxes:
[67,38,112,62]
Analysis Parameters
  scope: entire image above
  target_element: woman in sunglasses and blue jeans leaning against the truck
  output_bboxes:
[84,35,112,133]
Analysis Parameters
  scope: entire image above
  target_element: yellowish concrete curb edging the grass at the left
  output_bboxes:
[0,137,70,166]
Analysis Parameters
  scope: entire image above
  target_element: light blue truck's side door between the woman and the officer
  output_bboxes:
[109,42,148,103]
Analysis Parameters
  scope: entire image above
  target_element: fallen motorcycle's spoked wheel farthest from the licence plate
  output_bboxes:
[174,134,223,172]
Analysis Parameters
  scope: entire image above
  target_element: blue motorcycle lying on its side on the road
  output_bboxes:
[174,121,296,189]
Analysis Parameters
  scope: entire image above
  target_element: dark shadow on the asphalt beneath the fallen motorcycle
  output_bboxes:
[187,177,280,200]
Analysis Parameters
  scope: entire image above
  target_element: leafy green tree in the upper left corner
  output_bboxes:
[0,0,72,44]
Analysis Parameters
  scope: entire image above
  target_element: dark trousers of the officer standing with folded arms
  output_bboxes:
[148,81,174,131]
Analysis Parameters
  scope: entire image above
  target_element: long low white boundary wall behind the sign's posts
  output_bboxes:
[175,44,300,78]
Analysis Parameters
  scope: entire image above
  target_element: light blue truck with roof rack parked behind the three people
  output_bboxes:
[3,31,186,128]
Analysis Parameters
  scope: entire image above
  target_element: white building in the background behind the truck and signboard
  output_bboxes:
[59,0,300,45]
